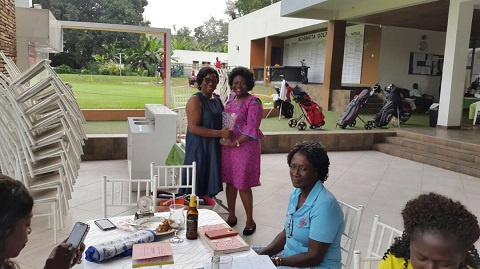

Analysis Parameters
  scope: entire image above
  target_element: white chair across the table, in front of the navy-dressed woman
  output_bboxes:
[150,162,197,210]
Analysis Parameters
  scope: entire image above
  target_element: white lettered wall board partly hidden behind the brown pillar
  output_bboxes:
[283,25,365,83]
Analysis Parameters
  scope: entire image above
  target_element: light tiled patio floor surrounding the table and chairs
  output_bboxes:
[15,151,480,269]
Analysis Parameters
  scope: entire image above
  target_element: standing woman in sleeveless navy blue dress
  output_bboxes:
[184,67,231,196]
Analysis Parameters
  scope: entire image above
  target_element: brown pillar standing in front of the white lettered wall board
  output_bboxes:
[320,21,347,109]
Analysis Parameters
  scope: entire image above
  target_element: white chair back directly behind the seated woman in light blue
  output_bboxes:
[338,201,363,268]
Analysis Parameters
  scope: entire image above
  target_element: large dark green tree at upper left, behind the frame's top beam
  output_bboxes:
[33,0,149,67]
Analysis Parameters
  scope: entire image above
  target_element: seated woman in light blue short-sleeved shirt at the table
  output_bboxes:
[258,141,344,269]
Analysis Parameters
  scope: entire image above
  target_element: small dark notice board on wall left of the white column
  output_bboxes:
[408,52,443,76]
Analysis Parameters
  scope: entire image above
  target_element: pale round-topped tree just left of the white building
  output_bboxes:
[193,17,228,52]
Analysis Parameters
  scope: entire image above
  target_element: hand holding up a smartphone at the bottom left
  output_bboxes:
[44,241,80,269]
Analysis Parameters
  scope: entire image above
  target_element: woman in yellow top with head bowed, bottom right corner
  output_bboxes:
[378,192,480,269]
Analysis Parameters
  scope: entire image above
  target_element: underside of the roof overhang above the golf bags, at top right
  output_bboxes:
[285,0,480,39]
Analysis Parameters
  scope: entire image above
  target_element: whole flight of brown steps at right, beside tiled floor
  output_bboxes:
[373,130,480,178]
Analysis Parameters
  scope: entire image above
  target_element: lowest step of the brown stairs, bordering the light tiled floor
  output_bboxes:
[373,143,480,177]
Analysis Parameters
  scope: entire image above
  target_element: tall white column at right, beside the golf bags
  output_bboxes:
[437,0,474,128]
